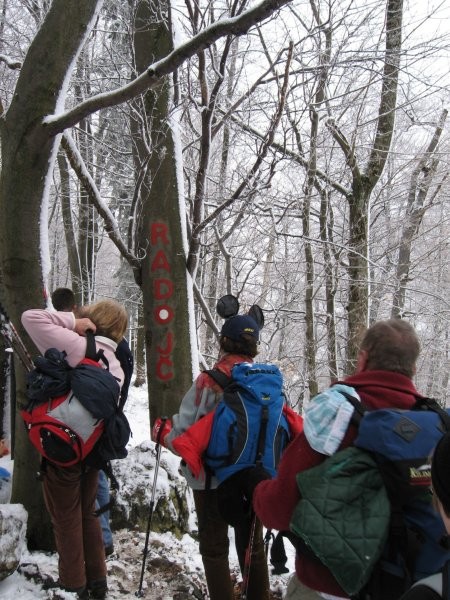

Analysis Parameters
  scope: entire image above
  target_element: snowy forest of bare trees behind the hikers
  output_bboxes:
[0,0,450,552]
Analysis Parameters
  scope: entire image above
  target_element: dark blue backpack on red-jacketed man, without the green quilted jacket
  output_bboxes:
[354,398,450,598]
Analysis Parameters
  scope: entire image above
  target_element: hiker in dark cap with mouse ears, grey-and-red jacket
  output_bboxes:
[152,315,302,600]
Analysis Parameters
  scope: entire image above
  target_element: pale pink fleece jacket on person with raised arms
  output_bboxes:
[22,309,124,387]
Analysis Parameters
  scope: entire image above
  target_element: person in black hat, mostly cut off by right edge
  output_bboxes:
[401,433,450,600]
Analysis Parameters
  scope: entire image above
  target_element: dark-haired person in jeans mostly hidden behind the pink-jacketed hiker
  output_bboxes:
[51,288,134,556]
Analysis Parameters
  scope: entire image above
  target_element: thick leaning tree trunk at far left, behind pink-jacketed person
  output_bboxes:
[0,0,100,549]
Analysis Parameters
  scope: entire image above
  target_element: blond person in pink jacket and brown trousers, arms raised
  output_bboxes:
[22,300,128,600]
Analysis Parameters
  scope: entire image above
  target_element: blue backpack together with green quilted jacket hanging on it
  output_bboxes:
[291,392,450,600]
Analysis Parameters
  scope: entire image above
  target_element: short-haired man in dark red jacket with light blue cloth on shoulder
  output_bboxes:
[253,319,420,600]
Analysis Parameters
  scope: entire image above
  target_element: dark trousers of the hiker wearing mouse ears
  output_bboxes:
[193,490,270,600]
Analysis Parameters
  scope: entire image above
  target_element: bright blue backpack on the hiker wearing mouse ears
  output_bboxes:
[204,363,289,482]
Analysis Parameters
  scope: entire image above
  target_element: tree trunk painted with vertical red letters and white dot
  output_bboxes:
[134,0,196,421]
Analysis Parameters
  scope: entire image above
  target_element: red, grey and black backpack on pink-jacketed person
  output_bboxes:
[20,332,120,467]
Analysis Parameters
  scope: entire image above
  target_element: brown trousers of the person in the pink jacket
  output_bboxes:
[43,463,106,589]
